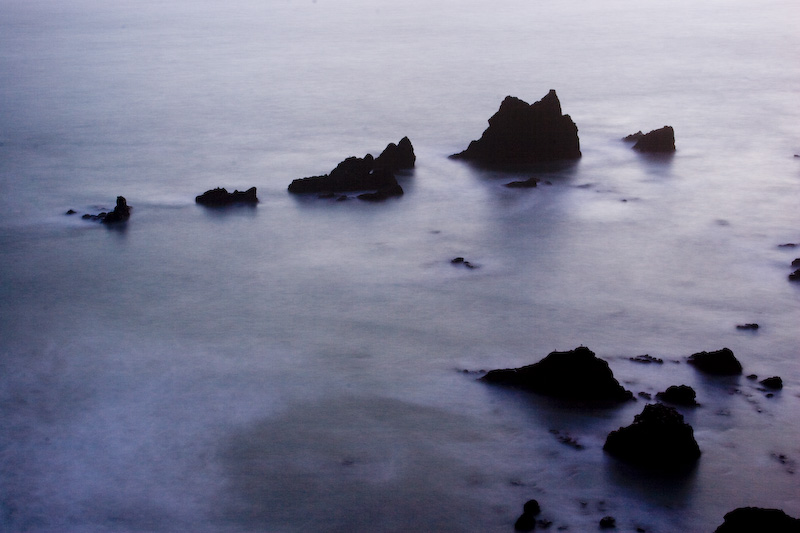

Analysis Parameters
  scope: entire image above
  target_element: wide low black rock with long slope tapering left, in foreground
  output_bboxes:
[481,346,633,402]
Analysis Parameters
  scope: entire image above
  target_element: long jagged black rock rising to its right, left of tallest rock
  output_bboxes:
[289,137,416,201]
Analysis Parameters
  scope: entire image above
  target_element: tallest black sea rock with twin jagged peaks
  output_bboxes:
[450,89,581,168]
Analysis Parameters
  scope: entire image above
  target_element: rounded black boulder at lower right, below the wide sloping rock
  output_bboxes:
[603,403,700,471]
